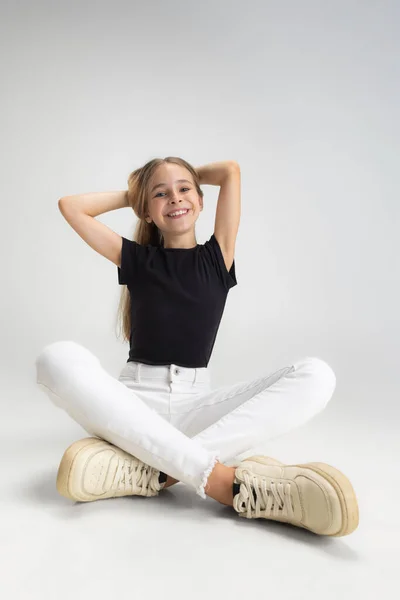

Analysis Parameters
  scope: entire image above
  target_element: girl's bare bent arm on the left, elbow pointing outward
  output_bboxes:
[58,190,129,267]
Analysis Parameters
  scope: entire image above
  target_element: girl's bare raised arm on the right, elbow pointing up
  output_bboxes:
[197,160,241,271]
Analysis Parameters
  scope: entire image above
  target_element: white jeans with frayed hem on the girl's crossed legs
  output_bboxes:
[35,341,336,498]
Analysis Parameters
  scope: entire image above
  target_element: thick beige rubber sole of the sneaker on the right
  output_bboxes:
[246,456,359,537]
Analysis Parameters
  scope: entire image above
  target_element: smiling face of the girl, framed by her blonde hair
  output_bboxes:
[145,163,203,239]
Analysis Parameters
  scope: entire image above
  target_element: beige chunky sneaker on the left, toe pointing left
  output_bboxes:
[56,437,164,502]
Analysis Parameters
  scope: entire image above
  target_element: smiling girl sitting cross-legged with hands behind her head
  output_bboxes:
[35,157,358,536]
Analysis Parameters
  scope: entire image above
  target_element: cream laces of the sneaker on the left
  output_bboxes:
[113,458,160,496]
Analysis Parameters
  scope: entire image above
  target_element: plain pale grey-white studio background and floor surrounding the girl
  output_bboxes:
[0,0,400,599]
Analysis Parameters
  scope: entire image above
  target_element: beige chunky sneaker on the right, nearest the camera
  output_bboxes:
[233,456,359,537]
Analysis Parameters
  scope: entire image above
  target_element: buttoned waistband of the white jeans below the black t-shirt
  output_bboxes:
[121,360,211,384]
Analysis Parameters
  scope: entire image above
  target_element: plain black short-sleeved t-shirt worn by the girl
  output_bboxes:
[117,234,237,367]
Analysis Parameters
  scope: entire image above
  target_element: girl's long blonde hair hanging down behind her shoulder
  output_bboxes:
[116,156,203,341]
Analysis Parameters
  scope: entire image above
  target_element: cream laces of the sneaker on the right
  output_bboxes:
[233,471,294,519]
